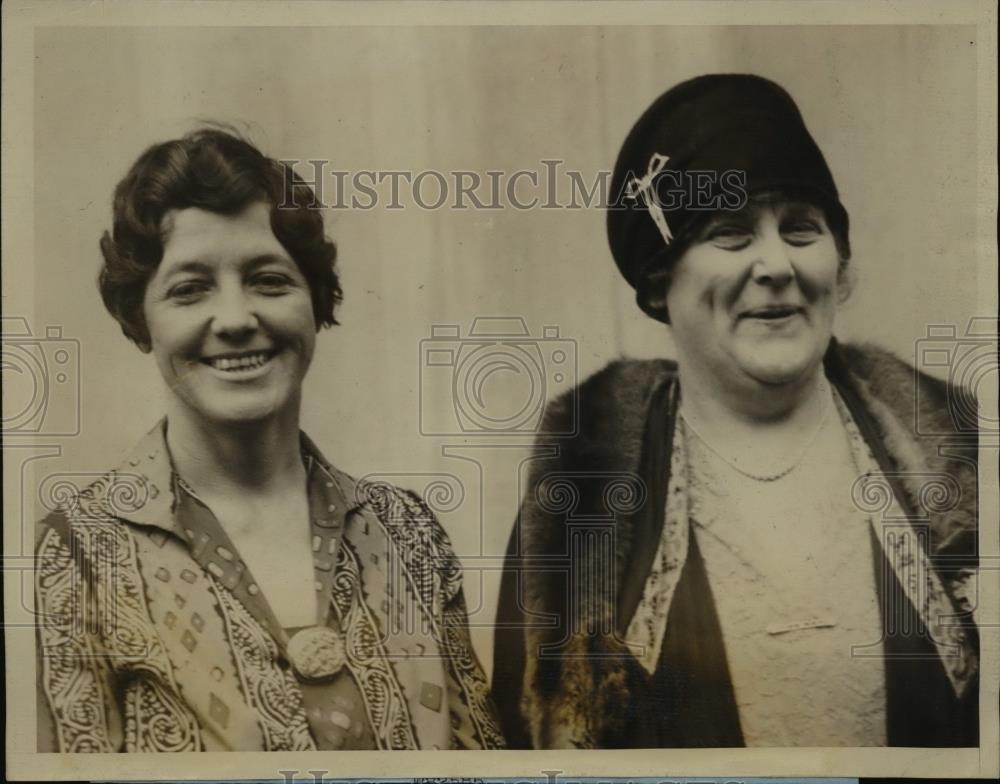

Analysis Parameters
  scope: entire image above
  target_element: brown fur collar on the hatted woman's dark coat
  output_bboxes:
[519,344,977,748]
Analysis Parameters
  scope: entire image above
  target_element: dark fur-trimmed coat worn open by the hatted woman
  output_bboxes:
[493,341,978,748]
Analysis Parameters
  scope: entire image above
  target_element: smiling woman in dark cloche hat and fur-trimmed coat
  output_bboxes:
[493,75,978,748]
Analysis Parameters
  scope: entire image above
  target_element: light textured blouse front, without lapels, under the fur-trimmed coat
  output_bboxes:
[684,391,886,746]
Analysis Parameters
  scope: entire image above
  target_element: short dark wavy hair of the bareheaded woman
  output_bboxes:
[98,126,343,351]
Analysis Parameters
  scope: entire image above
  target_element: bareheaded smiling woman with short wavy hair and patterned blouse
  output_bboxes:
[36,130,503,752]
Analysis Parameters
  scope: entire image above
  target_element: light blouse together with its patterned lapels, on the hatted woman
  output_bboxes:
[625,392,976,746]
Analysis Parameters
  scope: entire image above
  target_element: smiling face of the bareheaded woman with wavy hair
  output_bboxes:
[143,203,316,423]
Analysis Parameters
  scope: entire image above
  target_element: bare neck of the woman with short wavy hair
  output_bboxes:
[167,402,305,498]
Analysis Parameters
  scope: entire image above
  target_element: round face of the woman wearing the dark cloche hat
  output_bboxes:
[667,201,840,391]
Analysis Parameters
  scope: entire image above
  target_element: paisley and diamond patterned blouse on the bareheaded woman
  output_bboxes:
[36,423,504,753]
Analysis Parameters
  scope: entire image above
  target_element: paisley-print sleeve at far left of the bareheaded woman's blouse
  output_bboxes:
[38,488,202,751]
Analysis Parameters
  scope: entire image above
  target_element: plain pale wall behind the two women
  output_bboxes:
[25,26,990,668]
